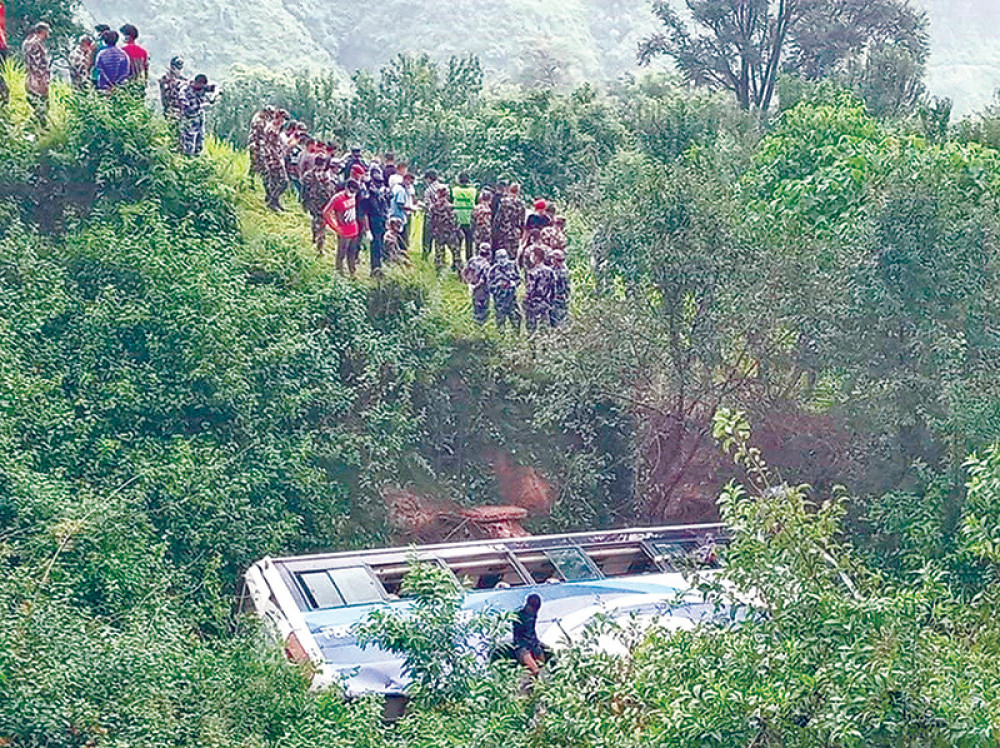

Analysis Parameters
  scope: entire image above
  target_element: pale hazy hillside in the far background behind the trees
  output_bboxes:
[84,0,1000,113]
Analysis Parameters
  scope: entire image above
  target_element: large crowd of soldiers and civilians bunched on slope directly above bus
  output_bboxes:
[248,106,570,332]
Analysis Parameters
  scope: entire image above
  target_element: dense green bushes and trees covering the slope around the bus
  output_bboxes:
[0,10,1000,748]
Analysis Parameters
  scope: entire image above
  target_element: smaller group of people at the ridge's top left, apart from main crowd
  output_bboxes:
[0,7,215,156]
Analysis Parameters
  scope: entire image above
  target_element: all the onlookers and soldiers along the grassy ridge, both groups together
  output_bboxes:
[0,6,570,332]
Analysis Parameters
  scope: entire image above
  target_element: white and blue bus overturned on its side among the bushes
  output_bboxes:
[246,525,724,696]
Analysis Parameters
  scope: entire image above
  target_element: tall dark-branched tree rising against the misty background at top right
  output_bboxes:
[639,0,927,111]
